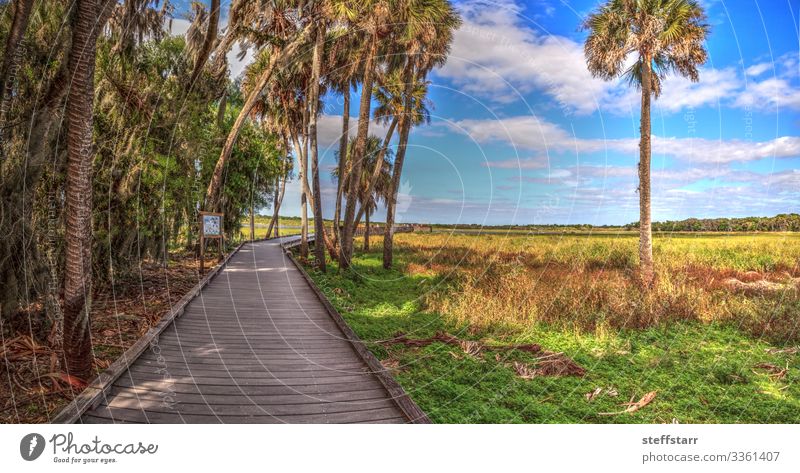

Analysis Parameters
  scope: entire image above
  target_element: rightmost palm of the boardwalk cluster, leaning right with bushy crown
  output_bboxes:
[383,0,461,269]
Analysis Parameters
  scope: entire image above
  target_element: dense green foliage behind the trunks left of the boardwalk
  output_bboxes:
[0,0,289,372]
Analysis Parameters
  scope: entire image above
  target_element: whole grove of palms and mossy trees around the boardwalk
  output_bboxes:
[0,0,460,379]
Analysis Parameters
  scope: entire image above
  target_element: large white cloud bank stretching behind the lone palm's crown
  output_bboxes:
[437,0,800,115]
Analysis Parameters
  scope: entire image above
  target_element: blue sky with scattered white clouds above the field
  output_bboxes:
[172,0,800,225]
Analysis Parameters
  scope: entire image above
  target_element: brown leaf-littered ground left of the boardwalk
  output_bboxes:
[0,255,206,423]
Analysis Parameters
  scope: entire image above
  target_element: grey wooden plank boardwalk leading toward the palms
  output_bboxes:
[69,236,427,423]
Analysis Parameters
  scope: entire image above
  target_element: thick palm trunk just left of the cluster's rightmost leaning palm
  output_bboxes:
[339,35,378,269]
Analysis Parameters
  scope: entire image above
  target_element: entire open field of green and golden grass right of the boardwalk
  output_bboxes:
[302,233,800,423]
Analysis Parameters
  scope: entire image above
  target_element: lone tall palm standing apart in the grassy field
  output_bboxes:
[583,0,709,287]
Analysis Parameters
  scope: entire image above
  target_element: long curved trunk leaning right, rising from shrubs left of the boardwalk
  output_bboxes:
[206,22,314,211]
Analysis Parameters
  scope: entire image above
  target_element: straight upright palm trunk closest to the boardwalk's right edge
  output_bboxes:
[308,24,326,273]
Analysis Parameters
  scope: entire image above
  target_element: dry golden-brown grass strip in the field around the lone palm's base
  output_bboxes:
[375,234,800,342]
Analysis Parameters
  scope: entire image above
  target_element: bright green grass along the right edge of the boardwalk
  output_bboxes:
[304,237,800,423]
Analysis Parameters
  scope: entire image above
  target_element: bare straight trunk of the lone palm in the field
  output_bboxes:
[639,58,655,287]
